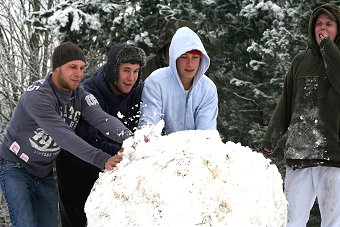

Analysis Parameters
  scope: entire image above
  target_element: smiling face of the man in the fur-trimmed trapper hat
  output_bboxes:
[116,63,140,94]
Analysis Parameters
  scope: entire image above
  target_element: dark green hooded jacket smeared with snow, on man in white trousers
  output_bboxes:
[263,4,340,168]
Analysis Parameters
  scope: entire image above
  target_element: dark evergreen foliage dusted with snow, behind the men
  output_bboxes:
[24,0,330,153]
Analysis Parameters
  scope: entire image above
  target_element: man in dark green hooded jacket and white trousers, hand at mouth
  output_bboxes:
[263,3,340,227]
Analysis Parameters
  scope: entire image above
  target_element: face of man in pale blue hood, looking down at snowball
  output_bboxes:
[176,52,201,89]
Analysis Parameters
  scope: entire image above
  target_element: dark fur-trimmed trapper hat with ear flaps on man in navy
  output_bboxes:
[104,43,146,85]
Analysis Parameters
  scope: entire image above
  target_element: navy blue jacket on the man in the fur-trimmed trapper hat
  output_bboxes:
[64,65,143,179]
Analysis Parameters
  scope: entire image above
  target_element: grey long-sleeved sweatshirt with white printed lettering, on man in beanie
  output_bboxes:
[0,75,132,177]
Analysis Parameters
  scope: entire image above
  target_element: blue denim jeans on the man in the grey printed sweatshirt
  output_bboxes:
[0,157,58,227]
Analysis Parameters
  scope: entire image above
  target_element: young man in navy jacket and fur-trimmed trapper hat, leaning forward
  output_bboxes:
[57,44,145,227]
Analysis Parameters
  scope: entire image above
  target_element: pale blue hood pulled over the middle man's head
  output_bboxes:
[169,27,210,89]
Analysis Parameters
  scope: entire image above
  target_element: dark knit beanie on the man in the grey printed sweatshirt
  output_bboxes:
[52,42,86,70]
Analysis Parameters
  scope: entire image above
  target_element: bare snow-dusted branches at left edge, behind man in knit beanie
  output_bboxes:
[0,0,52,138]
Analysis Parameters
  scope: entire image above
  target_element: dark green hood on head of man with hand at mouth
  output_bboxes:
[308,3,340,48]
